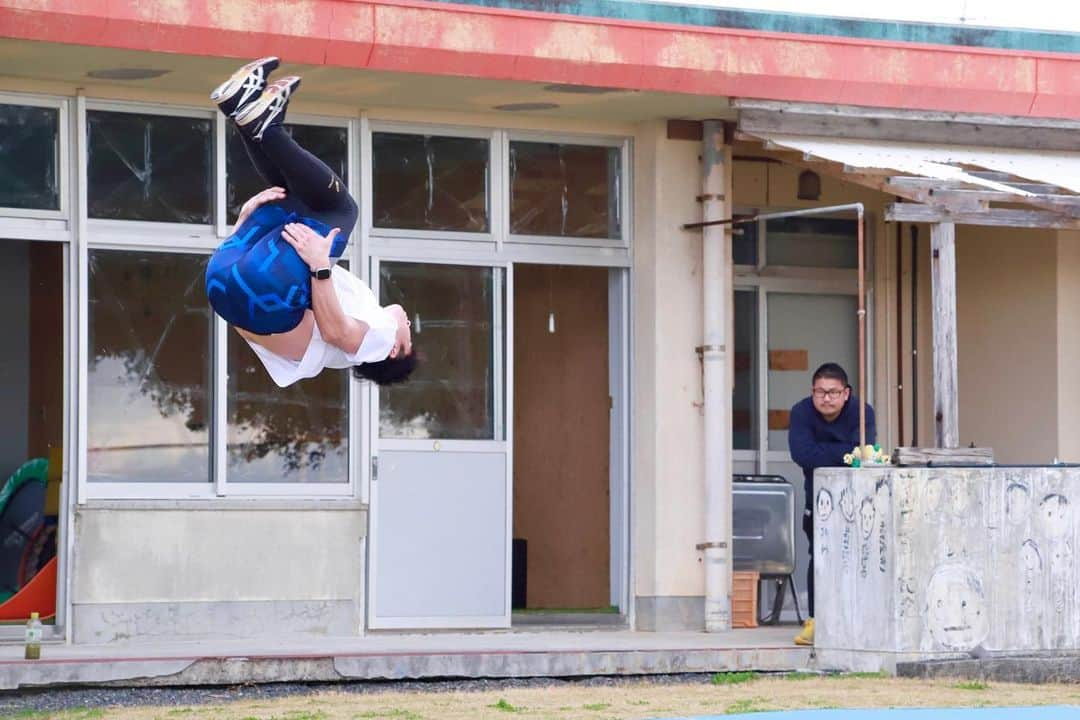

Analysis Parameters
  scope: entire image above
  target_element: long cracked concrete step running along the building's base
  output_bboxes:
[0,627,813,690]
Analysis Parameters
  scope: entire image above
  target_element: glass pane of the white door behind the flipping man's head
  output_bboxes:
[379,262,502,439]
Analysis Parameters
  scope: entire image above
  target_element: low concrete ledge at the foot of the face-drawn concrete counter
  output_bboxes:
[896,654,1080,683]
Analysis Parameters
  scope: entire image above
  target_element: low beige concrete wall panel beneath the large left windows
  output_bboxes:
[71,503,367,607]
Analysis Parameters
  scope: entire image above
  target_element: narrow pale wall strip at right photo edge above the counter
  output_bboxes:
[1057,231,1080,462]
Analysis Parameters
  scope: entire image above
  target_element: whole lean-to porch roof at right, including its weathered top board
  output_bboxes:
[738,103,1080,230]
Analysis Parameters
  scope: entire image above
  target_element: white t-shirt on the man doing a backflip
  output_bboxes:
[247,267,397,388]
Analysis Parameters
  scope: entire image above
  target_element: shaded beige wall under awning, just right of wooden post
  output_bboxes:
[959,226,1058,463]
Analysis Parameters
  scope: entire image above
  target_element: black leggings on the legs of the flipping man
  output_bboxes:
[240,125,360,240]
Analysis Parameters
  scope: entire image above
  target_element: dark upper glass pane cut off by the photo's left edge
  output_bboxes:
[0,105,60,210]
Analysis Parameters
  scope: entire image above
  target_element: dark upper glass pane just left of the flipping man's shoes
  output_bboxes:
[86,110,214,225]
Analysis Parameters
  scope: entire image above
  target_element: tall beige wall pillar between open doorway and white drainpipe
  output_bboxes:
[633,121,704,596]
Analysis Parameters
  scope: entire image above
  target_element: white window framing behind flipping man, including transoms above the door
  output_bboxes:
[71,101,633,504]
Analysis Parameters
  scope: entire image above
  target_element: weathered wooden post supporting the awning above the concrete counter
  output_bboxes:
[930,222,960,448]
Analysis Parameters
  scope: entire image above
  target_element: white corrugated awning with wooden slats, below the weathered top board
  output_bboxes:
[744,132,1080,229]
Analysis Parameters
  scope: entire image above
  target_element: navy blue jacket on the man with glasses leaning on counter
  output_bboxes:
[787,395,877,507]
